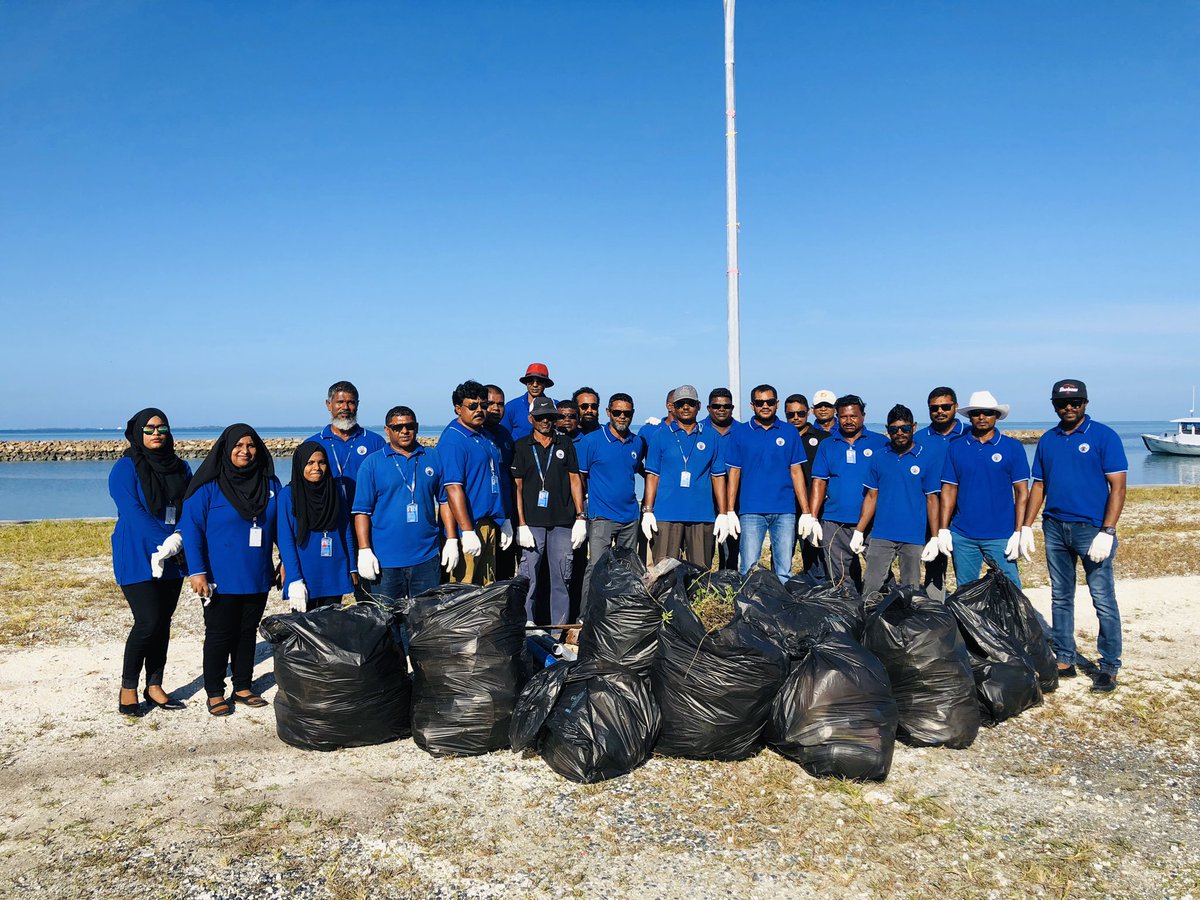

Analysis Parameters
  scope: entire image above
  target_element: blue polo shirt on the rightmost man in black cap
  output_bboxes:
[1033,415,1129,528]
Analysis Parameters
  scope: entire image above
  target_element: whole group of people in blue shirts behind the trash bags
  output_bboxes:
[109,362,1127,715]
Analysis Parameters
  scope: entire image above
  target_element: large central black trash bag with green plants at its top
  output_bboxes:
[650,572,788,760]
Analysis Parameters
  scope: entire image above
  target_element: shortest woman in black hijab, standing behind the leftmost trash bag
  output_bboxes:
[276,440,358,612]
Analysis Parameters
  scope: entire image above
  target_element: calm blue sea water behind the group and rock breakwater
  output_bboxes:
[0,421,1200,520]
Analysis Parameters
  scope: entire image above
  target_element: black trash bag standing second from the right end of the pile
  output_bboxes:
[863,586,979,749]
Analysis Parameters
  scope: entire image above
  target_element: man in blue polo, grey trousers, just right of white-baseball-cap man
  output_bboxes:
[809,391,888,590]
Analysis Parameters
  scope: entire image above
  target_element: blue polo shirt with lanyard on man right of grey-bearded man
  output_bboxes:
[354,445,446,569]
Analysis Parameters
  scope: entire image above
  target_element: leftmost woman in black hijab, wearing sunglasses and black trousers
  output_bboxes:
[108,407,192,715]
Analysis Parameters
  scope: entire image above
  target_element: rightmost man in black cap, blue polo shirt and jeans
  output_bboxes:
[1021,378,1129,692]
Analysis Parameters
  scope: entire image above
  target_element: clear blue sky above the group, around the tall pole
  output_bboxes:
[0,0,1200,430]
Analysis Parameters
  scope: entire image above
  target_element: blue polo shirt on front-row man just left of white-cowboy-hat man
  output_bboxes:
[863,440,942,544]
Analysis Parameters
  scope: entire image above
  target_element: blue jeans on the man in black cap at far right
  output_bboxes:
[1042,516,1121,674]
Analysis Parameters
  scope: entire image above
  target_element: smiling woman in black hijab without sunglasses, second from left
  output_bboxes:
[180,422,282,715]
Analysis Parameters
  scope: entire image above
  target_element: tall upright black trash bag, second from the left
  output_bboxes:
[408,577,529,756]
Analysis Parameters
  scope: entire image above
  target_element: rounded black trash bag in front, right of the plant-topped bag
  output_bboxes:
[767,632,899,781]
